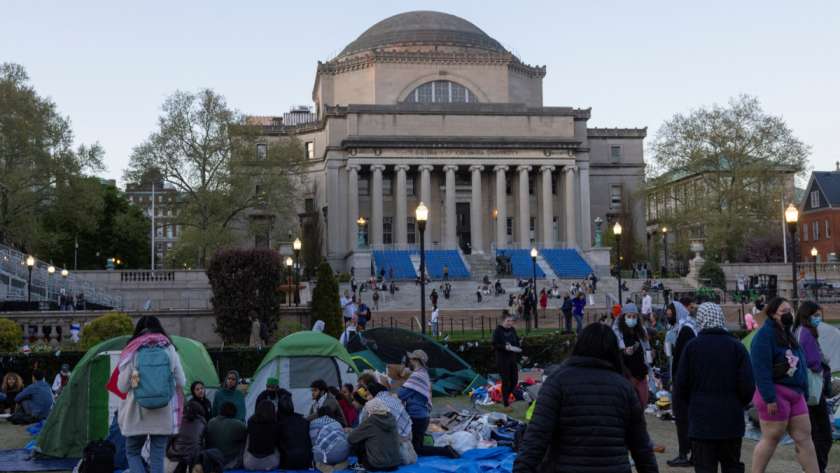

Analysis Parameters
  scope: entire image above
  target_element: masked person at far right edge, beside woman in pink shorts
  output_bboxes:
[794,301,833,472]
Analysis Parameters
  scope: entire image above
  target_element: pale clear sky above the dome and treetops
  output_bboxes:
[0,0,840,181]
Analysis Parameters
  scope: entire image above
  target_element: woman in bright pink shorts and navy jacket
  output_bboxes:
[750,297,819,473]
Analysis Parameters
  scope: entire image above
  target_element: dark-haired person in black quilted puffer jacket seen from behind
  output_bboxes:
[513,324,659,473]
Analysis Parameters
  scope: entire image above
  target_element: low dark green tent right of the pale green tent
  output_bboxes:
[347,327,487,396]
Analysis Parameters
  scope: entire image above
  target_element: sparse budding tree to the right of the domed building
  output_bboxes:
[651,95,809,260]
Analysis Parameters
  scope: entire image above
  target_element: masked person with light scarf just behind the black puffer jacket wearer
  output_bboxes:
[613,303,650,409]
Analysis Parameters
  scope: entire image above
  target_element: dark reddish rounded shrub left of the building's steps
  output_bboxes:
[207,248,283,343]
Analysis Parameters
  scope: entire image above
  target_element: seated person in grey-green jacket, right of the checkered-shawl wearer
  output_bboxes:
[347,398,402,471]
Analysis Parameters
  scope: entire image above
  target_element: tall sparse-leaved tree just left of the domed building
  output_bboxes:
[125,89,304,267]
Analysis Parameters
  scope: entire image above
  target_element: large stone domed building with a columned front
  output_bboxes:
[252,11,646,277]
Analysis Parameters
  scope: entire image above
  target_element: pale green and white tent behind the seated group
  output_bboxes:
[245,331,357,416]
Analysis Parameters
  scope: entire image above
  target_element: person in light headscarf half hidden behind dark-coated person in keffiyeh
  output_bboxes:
[666,297,699,468]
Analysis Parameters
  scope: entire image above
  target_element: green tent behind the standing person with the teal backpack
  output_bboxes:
[37,336,219,457]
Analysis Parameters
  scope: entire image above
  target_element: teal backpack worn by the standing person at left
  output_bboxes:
[134,346,175,409]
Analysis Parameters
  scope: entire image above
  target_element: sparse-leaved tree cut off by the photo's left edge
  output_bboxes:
[0,63,103,249]
